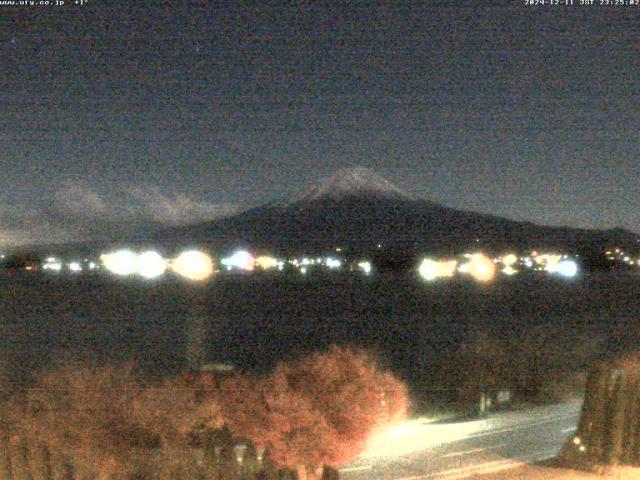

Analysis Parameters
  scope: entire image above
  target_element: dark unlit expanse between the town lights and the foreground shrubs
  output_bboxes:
[0,273,640,402]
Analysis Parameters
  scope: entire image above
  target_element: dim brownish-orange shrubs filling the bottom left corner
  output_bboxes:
[5,364,225,479]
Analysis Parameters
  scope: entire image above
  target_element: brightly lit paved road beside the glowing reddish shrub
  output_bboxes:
[340,402,581,480]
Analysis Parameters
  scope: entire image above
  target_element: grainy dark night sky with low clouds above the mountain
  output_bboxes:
[0,0,640,245]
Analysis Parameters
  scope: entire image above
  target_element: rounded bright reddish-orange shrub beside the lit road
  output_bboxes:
[224,346,408,474]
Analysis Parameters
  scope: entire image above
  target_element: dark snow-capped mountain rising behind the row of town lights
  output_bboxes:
[155,168,640,260]
